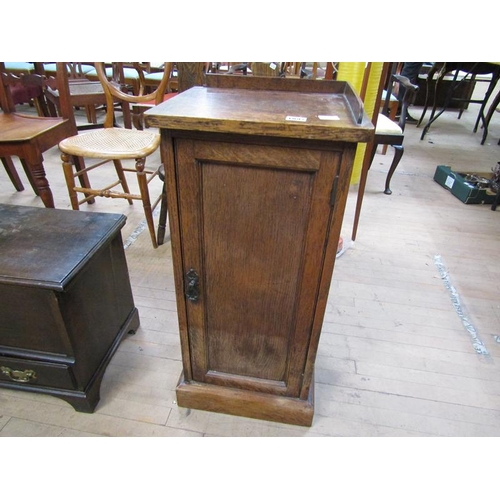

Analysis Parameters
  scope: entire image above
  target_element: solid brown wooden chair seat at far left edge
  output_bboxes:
[0,113,67,142]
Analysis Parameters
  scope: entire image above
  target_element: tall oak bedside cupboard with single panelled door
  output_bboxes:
[146,75,373,426]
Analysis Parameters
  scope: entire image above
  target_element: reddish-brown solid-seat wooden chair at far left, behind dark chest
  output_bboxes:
[0,63,86,208]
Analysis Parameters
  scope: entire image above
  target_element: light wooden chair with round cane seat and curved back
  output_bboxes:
[59,63,171,248]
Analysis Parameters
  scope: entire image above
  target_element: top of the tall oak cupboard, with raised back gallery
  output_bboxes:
[145,77,373,142]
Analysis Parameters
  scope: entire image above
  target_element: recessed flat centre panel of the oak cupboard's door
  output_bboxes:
[200,162,314,381]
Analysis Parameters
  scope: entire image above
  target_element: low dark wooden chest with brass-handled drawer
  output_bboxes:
[0,205,139,412]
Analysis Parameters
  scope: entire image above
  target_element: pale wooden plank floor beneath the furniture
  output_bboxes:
[0,87,500,437]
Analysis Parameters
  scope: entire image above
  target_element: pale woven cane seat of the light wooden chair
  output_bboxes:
[59,128,160,159]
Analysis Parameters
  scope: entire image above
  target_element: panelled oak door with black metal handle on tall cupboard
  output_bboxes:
[175,139,342,397]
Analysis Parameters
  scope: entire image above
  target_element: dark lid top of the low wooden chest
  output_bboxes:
[0,204,126,290]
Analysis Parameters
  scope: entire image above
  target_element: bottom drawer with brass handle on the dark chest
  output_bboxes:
[0,356,75,389]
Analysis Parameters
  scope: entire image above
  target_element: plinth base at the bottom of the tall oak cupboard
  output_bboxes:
[176,375,314,427]
